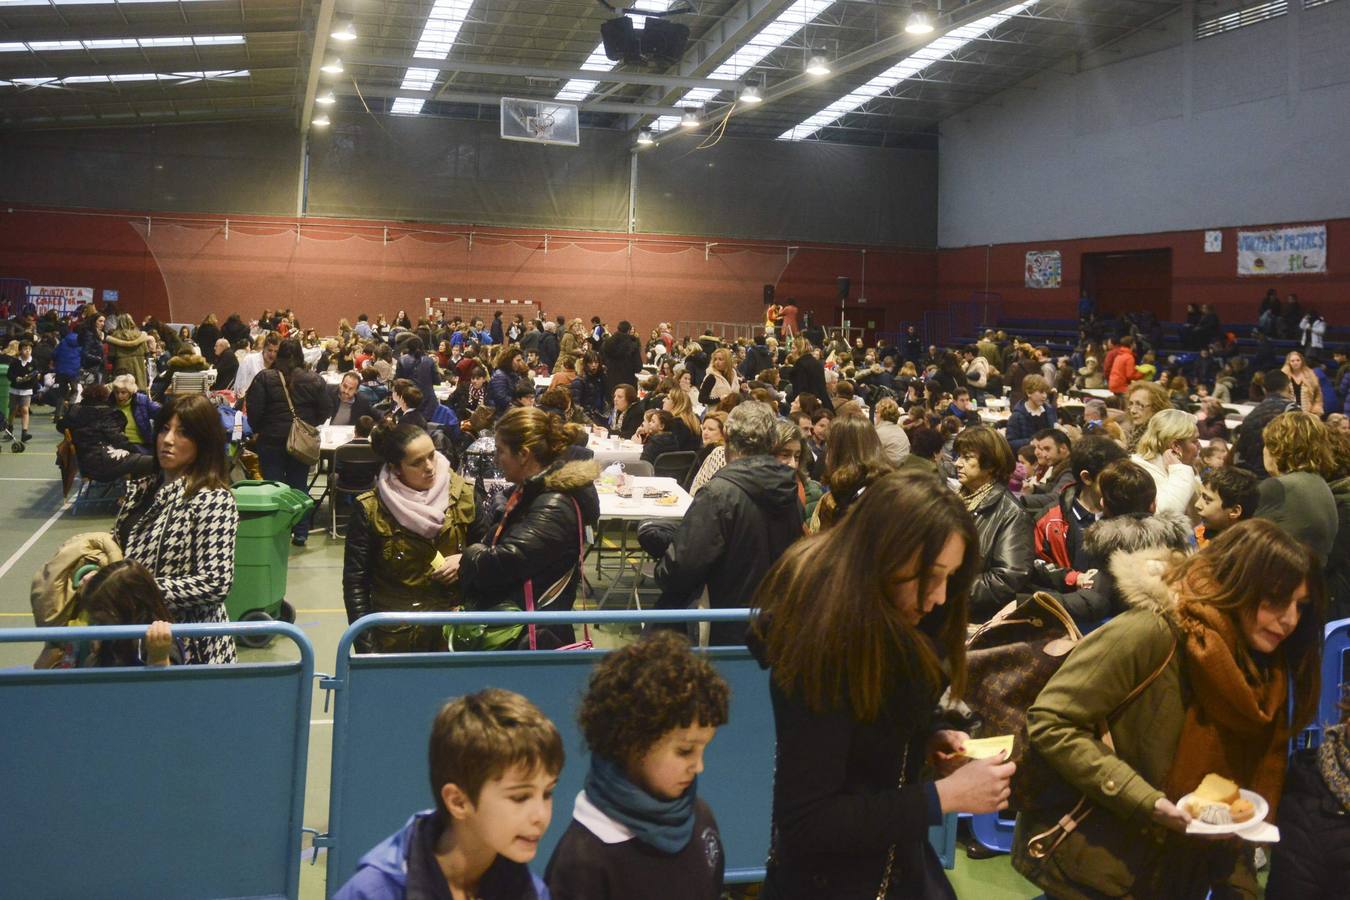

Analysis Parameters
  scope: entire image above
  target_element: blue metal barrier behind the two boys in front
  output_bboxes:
[315,610,956,895]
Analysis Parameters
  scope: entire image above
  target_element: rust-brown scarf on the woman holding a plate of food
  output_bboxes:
[1166,598,1289,819]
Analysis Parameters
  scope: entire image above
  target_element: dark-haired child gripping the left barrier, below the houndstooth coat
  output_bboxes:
[32,560,182,669]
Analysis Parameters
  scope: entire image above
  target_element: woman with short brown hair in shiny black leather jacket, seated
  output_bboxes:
[952,425,1034,623]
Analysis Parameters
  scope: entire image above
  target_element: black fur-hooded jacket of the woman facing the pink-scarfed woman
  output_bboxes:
[459,460,599,642]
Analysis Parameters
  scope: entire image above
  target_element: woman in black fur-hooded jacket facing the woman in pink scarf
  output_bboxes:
[451,406,599,646]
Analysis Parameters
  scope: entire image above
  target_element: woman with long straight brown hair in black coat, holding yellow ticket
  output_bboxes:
[749,472,1014,900]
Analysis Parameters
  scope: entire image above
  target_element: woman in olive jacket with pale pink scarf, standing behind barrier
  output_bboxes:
[342,424,477,653]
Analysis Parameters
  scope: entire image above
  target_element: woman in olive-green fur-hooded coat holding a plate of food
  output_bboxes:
[1013,519,1326,900]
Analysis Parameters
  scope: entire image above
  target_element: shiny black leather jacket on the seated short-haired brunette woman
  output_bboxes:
[971,484,1035,623]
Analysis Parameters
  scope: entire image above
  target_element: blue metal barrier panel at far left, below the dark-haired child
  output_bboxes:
[0,622,315,897]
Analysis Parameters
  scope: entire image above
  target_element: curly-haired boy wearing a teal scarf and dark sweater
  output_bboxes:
[544,631,728,900]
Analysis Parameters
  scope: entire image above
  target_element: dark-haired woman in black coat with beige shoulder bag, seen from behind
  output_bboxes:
[246,337,336,546]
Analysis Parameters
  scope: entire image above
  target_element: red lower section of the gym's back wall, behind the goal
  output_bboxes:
[0,209,937,333]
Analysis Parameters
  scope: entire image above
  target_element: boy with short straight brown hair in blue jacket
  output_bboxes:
[333,688,563,900]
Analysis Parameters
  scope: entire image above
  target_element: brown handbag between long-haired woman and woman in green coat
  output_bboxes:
[964,591,1083,810]
